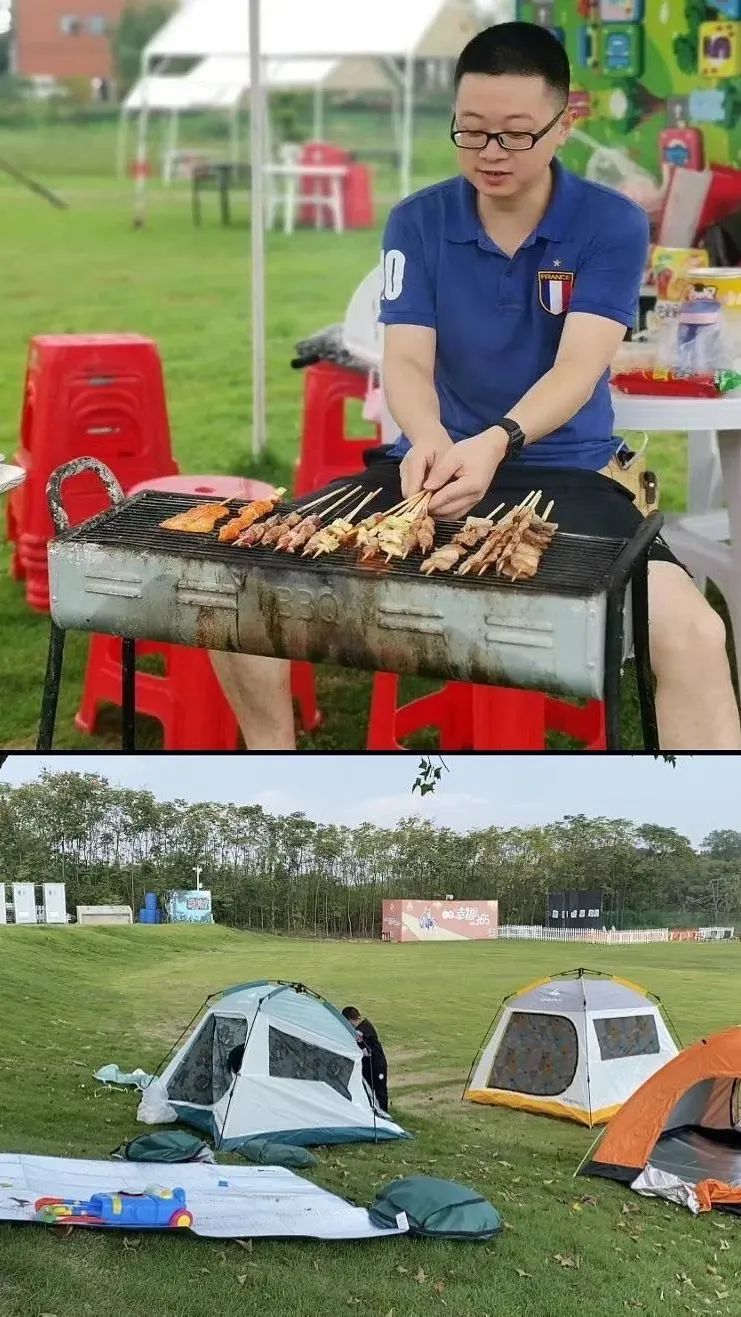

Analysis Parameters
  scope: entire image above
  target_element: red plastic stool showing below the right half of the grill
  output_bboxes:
[367,673,605,751]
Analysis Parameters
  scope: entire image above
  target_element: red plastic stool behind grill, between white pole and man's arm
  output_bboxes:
[295,361,382,498]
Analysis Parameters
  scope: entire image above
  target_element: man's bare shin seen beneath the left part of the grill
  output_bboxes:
[211,652,296,749]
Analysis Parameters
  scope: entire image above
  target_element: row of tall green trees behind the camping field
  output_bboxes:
[0,772,741,938]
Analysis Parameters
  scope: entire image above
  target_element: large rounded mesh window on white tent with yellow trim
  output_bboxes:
[488,1010,579,1097]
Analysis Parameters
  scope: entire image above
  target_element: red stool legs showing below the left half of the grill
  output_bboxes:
[75,636,321,751]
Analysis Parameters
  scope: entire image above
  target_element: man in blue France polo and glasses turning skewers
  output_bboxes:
[215,22,741,751]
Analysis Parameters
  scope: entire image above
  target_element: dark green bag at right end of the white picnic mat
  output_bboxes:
[370,1175,503,1241]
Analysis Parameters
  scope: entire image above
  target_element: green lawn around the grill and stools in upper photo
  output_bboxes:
[0,119,710,749]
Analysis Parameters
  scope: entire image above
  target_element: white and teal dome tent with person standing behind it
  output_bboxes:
[152,980,407,1150]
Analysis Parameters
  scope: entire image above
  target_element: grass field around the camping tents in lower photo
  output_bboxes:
[0,927,741,1317]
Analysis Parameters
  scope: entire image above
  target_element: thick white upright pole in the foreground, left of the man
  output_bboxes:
[250,0,267,457]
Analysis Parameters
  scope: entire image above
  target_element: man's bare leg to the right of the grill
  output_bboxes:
[649,561,741,751]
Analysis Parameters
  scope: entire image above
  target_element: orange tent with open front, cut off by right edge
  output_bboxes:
[582,1027,741,1212]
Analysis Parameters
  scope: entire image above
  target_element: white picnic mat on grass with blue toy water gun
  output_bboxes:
[0,1155,403,1239]
